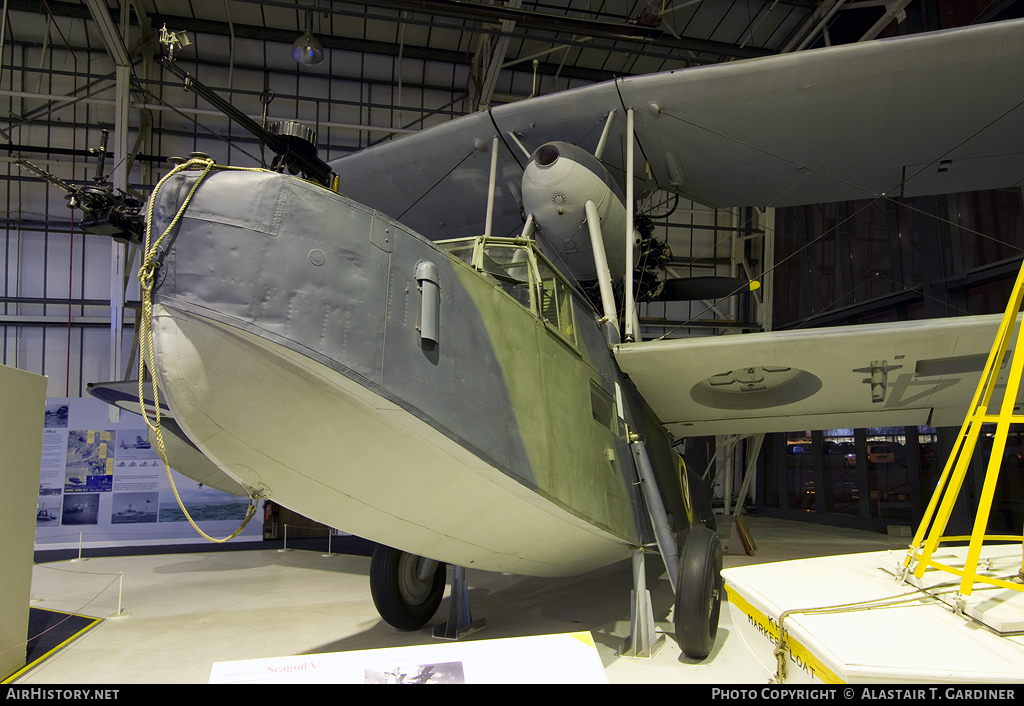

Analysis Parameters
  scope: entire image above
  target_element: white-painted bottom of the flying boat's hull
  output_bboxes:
[154,307,629,576]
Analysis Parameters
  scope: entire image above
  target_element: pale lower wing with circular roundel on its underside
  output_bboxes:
[614,315,1016,437]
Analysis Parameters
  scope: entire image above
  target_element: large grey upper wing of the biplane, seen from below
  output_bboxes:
[331,20,1024,239]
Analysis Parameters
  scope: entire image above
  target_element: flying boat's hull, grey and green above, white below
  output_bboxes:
[142,172,671,576]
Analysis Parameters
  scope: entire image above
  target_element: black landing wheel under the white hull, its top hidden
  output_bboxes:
[370,544,446,630]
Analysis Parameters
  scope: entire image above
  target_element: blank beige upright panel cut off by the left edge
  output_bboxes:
[0,366,46,680]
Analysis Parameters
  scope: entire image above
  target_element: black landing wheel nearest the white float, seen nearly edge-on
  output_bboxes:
[675,526,723,660]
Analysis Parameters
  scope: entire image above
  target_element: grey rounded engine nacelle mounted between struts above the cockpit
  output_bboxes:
[522,142,626,282]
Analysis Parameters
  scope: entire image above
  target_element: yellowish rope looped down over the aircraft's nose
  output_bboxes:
[138,158,266,544]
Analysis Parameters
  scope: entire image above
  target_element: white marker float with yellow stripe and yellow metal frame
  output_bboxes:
[722,260,1024,684]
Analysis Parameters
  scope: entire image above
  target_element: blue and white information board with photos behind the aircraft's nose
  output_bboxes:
[36,398,262,549]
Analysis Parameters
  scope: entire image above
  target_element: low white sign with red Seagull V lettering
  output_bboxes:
[210,632,608,683]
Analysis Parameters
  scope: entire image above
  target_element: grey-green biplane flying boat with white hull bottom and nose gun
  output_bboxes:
[81,22,1024,658]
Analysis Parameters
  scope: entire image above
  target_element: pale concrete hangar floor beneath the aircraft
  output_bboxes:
[14,517,907,684]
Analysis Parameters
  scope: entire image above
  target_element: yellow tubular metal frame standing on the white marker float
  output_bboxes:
[903,261,1024,595]
